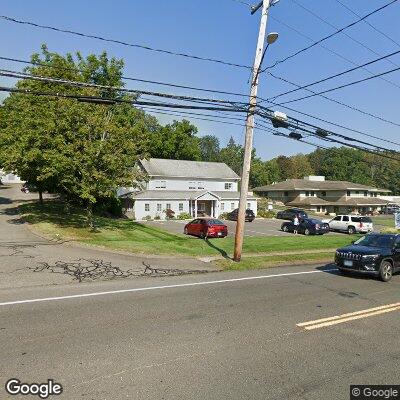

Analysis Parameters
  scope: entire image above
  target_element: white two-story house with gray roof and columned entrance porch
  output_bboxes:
[119,158,257,220]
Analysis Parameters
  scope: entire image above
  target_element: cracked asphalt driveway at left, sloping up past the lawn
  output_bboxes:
[0,185,215,289]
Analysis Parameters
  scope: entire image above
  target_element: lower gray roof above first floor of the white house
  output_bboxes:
[131,190,256,200]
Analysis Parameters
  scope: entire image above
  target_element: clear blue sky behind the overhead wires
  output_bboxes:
[0,0,400,159]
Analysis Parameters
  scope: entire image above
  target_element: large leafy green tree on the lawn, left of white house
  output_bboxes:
[0,46,154,224]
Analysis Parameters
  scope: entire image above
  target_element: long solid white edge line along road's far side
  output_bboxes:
[0,268,337,307]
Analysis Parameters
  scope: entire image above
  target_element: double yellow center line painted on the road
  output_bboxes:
[296,303,400,331]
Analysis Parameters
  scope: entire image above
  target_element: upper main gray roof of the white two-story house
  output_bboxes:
[140,158,239,179]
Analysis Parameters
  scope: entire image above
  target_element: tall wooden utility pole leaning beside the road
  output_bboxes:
[233,0,271,261]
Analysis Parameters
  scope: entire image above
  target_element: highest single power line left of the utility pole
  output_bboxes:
[0,15,252,70]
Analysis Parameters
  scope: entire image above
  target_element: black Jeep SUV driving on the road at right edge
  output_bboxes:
[335,233,400,282]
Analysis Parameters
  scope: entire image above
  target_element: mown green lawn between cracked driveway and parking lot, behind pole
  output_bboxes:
[19,201,356,257]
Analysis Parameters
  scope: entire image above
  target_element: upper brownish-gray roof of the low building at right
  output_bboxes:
[253,179,390,193]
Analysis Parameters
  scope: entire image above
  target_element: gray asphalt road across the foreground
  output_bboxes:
[0,267,400,400]
